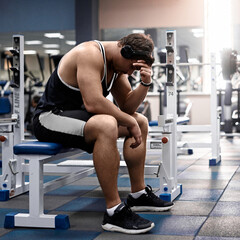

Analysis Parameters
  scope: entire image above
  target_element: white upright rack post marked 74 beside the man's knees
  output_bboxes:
[149,31,182,201]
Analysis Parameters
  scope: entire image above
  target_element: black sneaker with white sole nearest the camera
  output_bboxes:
[102,203,155,234]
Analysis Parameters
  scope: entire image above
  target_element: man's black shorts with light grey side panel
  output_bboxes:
[33,110,94,153]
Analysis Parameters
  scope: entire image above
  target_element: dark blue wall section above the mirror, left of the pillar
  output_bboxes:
[0,0,75,33]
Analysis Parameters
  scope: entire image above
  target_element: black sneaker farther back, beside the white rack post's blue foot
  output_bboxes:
[127,185,174,212]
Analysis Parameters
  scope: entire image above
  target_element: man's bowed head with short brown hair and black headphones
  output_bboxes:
[118,33,154,66]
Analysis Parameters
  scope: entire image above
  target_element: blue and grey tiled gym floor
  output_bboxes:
[0,134,240,240]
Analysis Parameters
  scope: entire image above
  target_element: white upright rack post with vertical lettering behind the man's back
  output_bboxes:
[0,35,24,200]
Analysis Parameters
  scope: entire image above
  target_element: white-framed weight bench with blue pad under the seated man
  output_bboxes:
[4,141,94,229]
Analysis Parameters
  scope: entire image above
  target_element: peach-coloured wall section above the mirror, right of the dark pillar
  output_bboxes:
[99,0,204,29]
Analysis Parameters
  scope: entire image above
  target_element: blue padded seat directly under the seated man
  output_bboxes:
[13,141,63,155]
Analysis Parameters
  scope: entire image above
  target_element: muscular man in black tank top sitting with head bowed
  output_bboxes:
[34,34,173,234]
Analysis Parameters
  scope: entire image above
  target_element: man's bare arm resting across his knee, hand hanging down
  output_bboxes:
[77,48,142,147]
